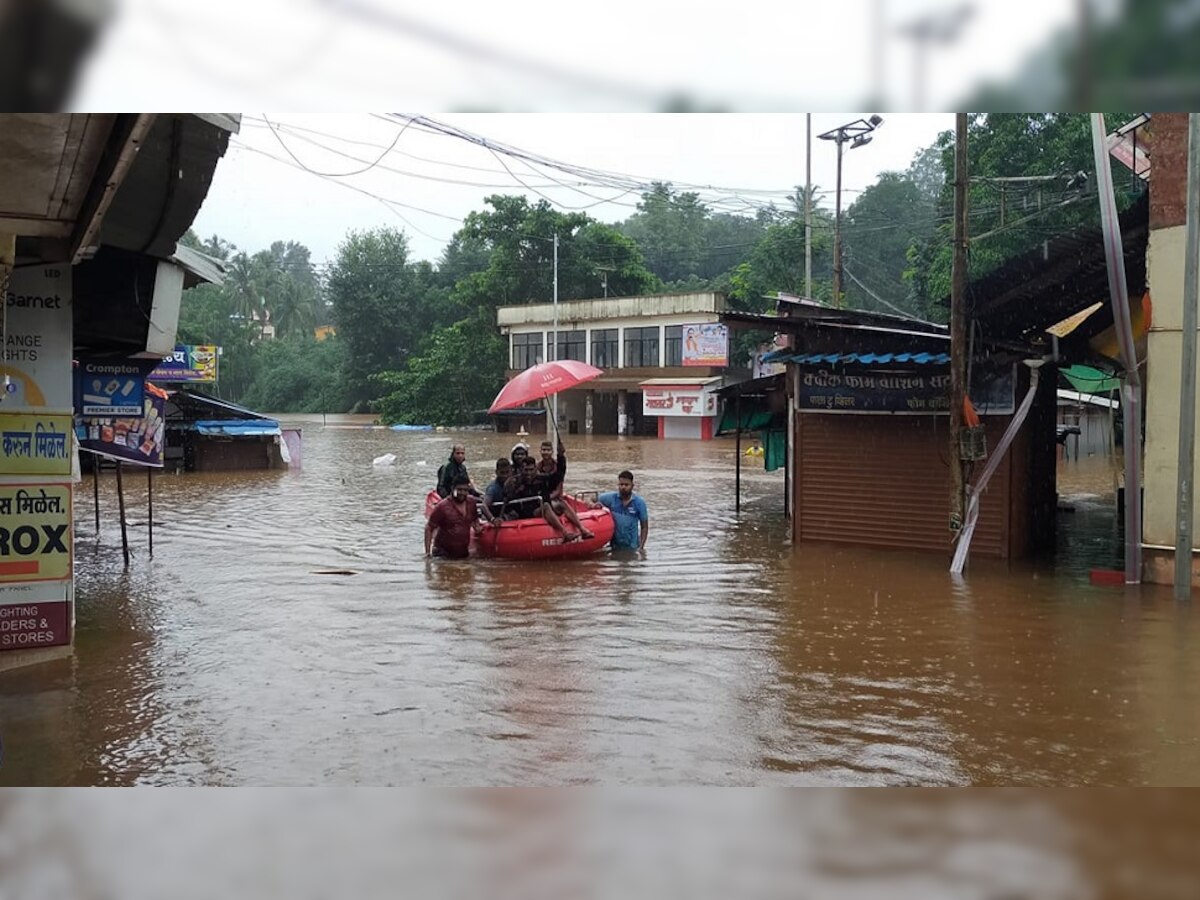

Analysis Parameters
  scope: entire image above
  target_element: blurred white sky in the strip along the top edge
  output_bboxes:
[73,0,1084,112]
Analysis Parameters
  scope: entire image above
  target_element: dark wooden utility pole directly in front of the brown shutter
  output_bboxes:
[948,113,968,534]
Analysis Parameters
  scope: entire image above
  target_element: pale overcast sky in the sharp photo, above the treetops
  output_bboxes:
[193,113,954,263]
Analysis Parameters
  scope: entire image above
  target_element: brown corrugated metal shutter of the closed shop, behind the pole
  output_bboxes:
[797,413,1009,557]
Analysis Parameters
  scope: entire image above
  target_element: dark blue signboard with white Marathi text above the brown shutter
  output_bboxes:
[796,370,1015,415]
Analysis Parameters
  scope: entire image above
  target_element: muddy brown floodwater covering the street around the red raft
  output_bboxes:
[0,416,1200,785]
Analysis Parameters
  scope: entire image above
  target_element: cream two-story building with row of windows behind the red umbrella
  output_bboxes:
[497,293,730,440]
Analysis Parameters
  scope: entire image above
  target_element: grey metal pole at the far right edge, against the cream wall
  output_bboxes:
[1171,113,1200,600]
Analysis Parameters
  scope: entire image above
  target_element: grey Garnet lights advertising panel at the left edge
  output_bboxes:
[0,263,72,413]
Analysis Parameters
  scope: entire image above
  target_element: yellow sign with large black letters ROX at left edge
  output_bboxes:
[0,482,72,584]
